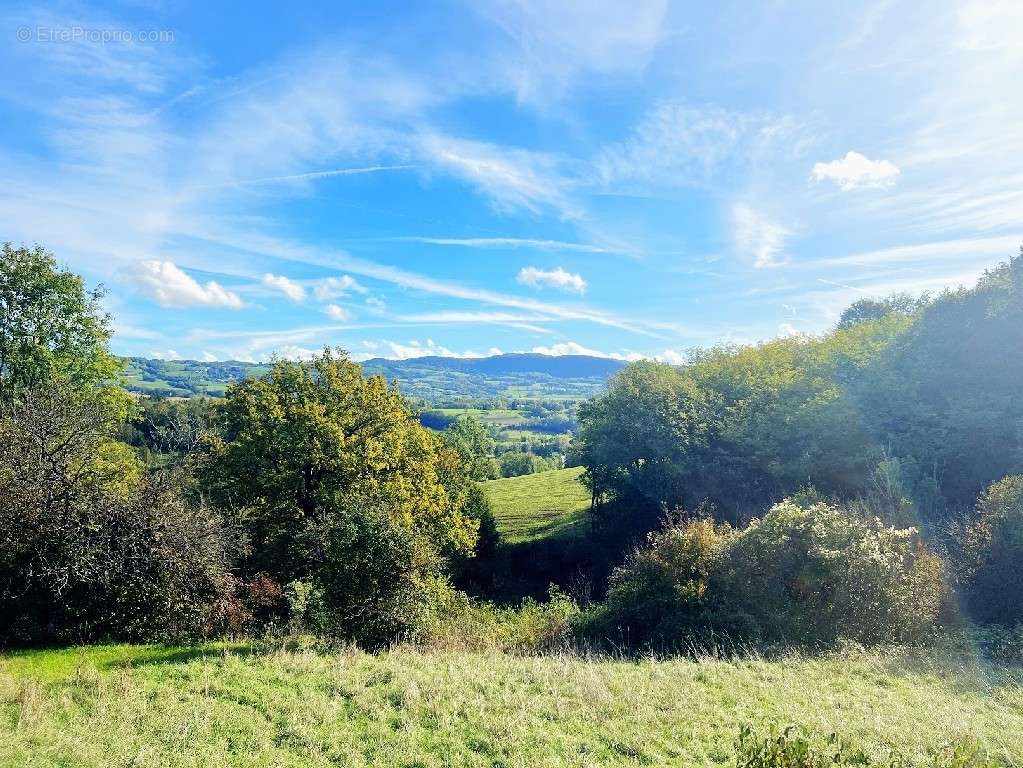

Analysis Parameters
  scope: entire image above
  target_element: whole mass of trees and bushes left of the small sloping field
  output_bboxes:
[0,245,494,644]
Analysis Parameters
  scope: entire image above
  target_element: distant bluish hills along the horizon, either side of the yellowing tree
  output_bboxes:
[127,353,625,406]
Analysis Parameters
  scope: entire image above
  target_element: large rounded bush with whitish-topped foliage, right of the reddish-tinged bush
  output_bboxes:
[720,501,947,643]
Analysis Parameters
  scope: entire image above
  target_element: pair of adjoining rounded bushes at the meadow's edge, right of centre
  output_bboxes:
[587,500,949,648]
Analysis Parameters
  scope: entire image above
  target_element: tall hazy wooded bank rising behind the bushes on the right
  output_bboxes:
[579,258,1023,523]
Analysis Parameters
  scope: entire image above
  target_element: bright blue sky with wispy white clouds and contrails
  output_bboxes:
[0,0,1023,361]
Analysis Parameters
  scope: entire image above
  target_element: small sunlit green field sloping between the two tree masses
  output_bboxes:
[485,466,589,544]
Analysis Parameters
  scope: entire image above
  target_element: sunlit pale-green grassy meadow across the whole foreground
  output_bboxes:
[0,645,1023,768]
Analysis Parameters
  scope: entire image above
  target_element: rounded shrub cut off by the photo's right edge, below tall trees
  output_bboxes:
[964,475,1023,626]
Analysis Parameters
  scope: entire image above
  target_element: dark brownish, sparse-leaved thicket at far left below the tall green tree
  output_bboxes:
[0,386,233,643]
